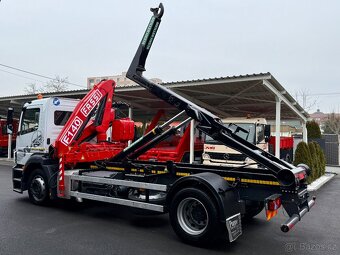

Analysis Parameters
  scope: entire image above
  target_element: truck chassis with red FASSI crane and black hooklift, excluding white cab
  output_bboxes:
[13,4,315,244]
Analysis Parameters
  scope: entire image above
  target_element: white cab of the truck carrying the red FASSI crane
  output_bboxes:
[14,97,79,165]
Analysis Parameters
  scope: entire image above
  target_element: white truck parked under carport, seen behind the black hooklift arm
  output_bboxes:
[202,117,270,167]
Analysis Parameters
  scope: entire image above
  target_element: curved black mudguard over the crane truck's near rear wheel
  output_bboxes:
[166,173,241,223]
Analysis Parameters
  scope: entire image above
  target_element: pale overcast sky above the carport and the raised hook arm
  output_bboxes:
[0,0,340,112]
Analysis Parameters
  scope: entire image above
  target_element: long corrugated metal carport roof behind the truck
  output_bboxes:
[0,73,308,122]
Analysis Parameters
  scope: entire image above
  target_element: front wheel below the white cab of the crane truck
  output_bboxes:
[28,168,50,205]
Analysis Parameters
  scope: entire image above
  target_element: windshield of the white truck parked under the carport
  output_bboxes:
[205,123,255,144]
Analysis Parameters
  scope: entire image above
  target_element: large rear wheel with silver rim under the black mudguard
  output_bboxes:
[169,188,225,245]
